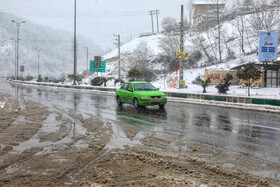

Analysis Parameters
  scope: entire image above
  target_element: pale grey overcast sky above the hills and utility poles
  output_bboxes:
[0,0,187,50]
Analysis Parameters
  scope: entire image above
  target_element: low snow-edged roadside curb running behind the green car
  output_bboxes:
[8,80,280,114]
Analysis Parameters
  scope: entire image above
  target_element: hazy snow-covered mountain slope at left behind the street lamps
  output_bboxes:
[0,12,102,77]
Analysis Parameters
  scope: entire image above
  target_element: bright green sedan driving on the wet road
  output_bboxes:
[116,82,167,108]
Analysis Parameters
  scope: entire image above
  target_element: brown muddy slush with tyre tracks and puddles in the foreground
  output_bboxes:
[0,94,280,187]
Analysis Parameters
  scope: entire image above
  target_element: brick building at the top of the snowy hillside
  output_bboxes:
[192,0,226,26]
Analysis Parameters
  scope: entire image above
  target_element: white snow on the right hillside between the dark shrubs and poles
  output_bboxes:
[104,9,270,83]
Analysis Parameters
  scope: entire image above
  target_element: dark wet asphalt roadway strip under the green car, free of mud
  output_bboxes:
[0,79,280,179]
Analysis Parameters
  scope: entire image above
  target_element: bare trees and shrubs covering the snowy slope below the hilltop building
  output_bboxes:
[104,1,280,83]
